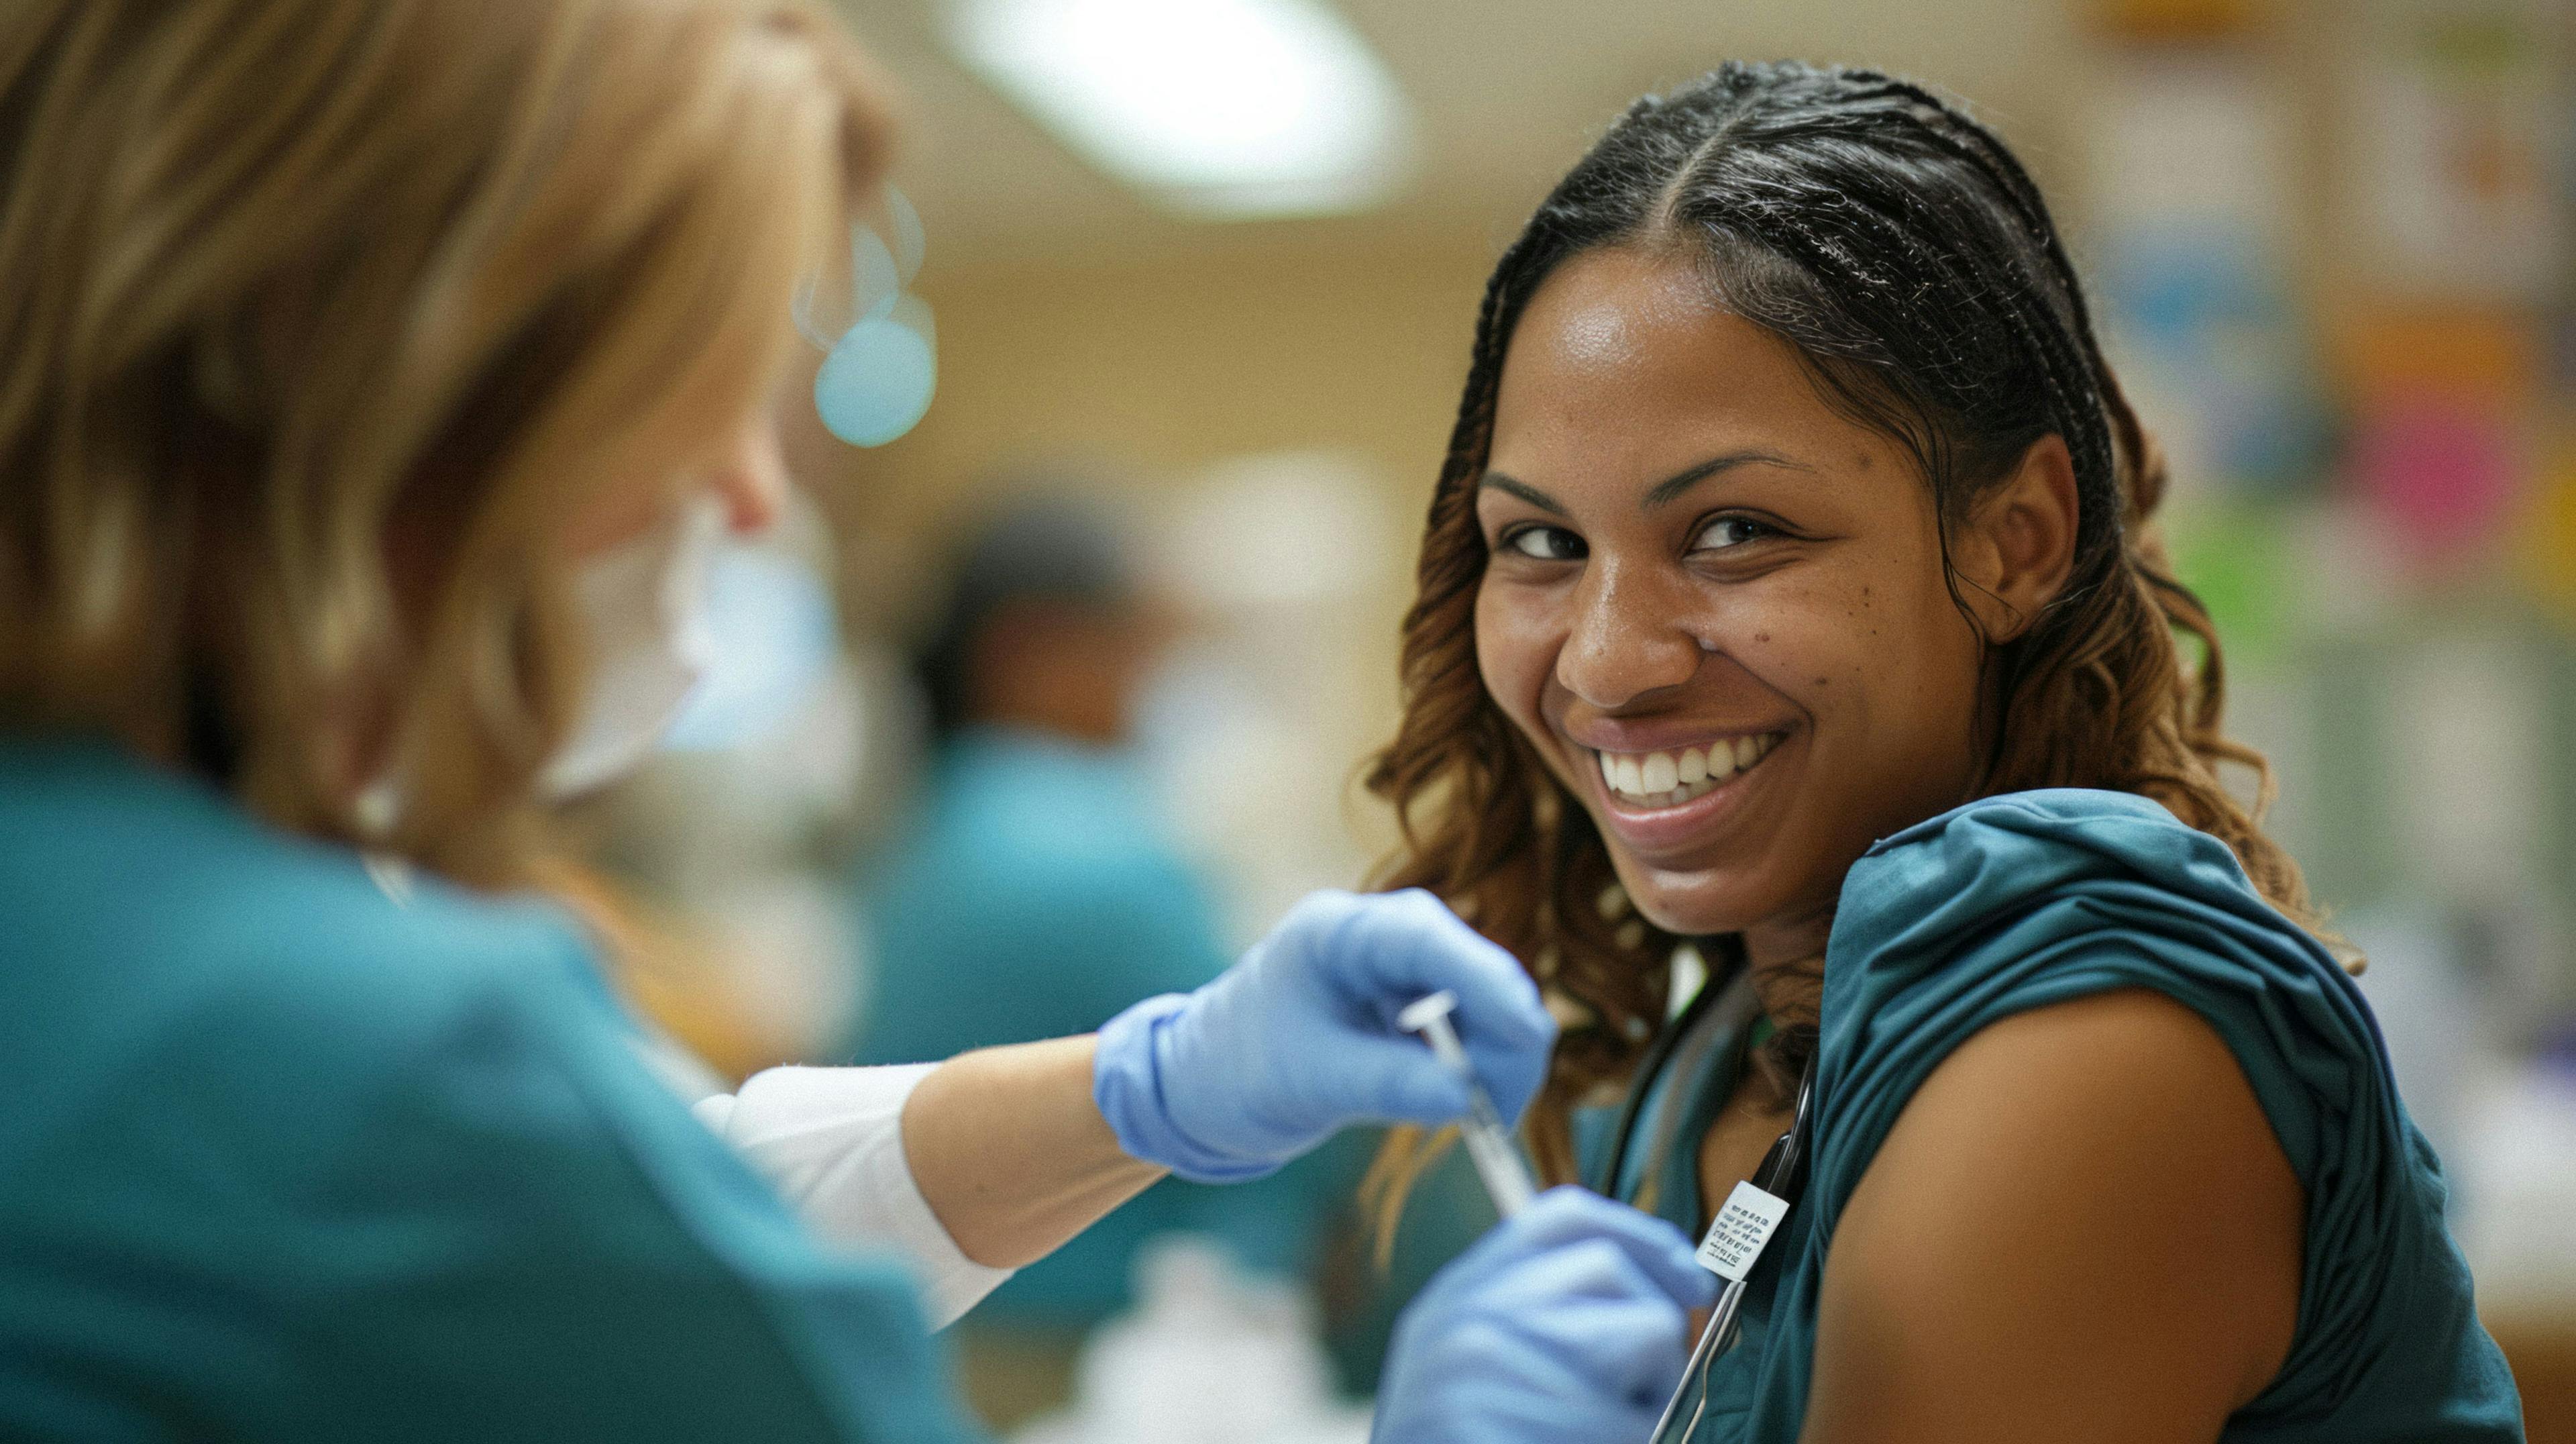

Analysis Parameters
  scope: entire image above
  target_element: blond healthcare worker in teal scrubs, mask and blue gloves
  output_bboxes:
[0,0,1705,1444]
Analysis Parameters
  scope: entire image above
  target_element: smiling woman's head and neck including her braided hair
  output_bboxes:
[1371,64,2313,1174]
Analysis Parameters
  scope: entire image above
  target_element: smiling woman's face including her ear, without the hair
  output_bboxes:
[1476,264,2019,969]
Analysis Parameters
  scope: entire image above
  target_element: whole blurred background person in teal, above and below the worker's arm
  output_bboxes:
[850,487,1358,1416]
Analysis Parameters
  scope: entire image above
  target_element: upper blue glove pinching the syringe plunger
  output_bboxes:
[1092,890,1556,1184]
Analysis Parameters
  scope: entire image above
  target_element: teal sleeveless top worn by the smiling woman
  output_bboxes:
[1595,789,2522,1444]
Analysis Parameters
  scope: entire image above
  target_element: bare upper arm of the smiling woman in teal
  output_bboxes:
[1806,990,2306,1444]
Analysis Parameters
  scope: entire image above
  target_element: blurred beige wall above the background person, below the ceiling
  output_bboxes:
[798,238,1494,552]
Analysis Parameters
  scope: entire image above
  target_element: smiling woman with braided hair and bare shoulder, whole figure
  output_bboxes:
[1371,64,2520,1444]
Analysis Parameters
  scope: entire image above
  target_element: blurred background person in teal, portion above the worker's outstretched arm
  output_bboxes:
[850,501,1195,1139]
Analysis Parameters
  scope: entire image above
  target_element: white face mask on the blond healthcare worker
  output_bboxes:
[539,493,724,799]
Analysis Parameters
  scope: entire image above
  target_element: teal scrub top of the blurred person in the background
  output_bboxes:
[853,727,1358,1331]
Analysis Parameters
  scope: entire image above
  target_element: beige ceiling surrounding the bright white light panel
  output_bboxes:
[840,0,2086,263]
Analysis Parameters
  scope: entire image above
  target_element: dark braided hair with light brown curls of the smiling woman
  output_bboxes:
[1368,62,2349,1217]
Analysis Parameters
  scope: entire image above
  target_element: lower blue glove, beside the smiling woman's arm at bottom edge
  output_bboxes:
[1368,1189,1715,1444]
